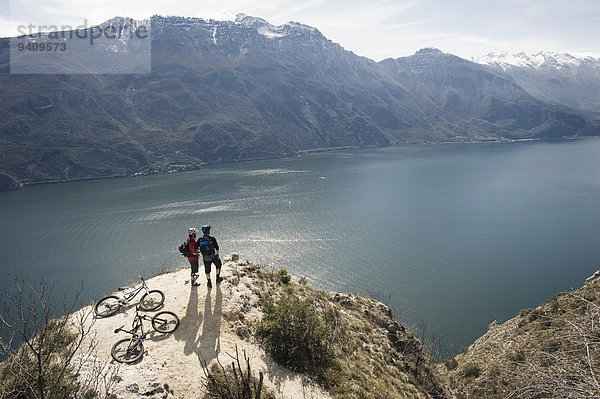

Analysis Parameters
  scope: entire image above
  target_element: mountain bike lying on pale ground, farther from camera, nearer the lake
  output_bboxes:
[94,275,165,317]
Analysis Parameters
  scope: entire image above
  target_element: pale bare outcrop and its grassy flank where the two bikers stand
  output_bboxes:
[62,261,447,399]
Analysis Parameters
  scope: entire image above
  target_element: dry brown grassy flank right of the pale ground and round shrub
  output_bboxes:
[230,265,448,399]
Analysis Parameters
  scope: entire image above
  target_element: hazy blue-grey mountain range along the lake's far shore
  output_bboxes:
[0,14,600,189]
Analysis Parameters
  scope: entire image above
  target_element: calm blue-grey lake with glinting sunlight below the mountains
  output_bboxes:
[0,140,600,356]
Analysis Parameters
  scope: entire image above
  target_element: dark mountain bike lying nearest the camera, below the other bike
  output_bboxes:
[110,306,179,363]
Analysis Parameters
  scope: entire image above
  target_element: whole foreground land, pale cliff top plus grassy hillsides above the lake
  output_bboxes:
[0,256,600,399]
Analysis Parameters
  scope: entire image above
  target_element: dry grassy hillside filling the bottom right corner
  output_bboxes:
[440,273,600,399]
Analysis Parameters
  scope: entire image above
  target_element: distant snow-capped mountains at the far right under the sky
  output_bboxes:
[472,52,600,112]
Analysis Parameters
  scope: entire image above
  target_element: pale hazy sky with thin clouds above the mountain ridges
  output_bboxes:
[0,0,600,61]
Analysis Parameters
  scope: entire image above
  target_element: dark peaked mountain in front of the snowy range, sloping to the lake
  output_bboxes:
[381,49,591,140]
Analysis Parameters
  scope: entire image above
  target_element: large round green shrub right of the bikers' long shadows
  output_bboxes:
[257,295,340,376]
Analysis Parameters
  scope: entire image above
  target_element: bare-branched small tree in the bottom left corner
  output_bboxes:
[0,279,102,399]
